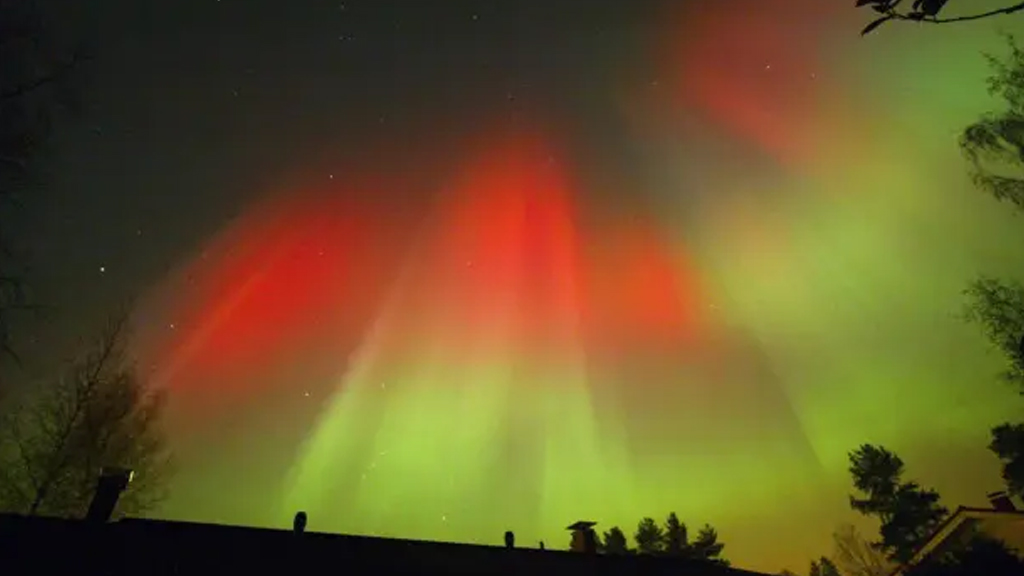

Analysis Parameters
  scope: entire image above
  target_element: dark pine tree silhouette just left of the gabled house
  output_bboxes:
[850,444,947,563]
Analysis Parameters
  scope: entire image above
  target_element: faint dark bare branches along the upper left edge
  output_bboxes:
[0,0,86,360]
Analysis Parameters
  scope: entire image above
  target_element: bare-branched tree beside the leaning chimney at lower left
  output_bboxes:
[0,319,171,518]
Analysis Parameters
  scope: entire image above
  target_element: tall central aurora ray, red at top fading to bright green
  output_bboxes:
[287,133,638,540]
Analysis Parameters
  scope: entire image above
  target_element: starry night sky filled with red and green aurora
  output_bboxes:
[4,0,1024,571]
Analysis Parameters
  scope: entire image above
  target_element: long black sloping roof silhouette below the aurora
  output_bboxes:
[0,515,762,576]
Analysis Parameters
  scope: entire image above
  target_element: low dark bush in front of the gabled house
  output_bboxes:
[905,535,1024,576]
